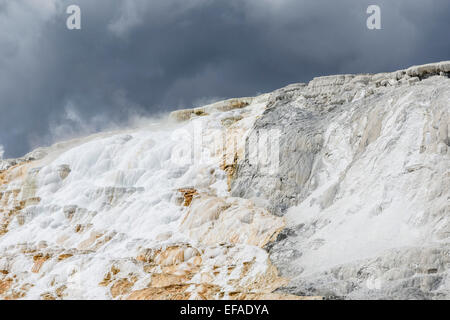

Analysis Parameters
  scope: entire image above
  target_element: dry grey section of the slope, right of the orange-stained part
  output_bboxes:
[232,63,450,299]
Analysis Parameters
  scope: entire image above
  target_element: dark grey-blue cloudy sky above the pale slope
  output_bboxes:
[0,0,450,157]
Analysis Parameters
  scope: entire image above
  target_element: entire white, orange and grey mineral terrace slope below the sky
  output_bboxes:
[0,62,450,299]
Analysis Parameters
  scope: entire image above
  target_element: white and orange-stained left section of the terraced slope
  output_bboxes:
[0,90,302,299]
